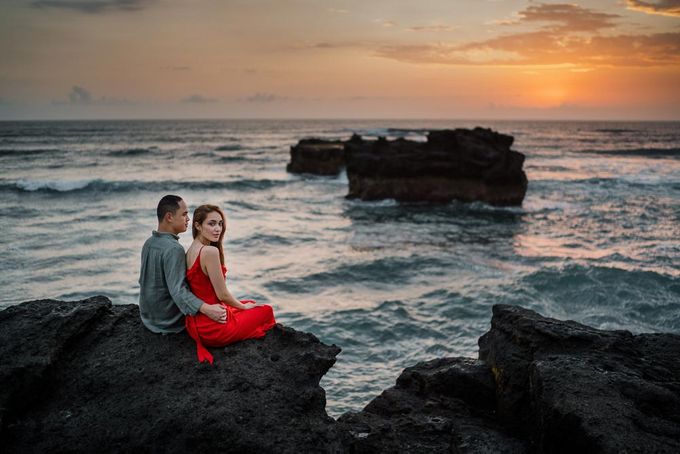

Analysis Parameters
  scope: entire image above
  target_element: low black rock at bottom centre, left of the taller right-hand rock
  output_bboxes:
[338,358,526,454]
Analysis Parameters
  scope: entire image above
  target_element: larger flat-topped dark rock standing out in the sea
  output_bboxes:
[345,128,527,205]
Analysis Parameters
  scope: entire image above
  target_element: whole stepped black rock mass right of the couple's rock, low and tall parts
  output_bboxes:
[338,306,680,453]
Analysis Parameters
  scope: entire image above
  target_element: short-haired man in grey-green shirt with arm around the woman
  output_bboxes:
[139,195,227,333]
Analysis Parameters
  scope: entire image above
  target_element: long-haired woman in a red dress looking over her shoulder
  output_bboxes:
[185,205,276,364]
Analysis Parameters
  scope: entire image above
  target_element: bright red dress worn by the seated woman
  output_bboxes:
[184,248,276,364]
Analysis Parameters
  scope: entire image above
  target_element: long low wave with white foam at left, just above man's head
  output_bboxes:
[0,178,289,193]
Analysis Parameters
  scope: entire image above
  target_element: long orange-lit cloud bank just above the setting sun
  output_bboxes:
[376,2,680,67]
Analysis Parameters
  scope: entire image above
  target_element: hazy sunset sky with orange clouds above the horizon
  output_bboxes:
[0,0,680,120]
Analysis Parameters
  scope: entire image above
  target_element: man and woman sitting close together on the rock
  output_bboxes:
[139,195,276,364]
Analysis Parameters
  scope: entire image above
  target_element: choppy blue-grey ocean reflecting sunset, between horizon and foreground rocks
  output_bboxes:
[0,120,680,416]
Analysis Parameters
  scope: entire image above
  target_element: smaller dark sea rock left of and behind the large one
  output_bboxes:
[286,139,345,175]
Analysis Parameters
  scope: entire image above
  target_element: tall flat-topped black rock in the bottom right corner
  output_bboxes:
[479,306,680,453]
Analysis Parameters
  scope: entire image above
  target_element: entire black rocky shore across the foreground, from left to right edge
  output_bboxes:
[0,297,680,453]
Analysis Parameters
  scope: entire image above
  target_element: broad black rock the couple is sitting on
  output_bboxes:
[0,297,341,453]
